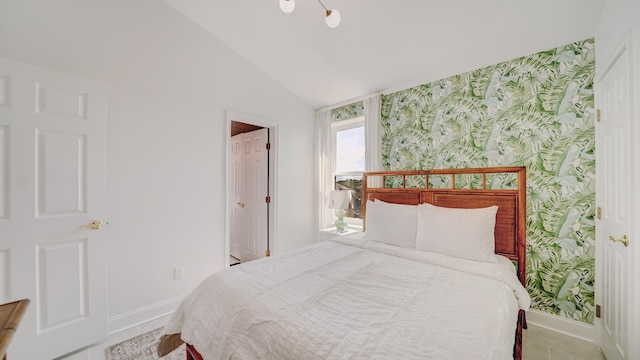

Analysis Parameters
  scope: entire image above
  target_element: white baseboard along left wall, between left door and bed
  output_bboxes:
[107,296,184,335]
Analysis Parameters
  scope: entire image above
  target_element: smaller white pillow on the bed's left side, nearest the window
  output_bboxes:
[364,200,418,249]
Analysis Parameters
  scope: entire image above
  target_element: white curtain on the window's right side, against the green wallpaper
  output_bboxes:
[363,94,383,187]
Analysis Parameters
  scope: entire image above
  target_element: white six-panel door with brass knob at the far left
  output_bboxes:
[0,58,107,359]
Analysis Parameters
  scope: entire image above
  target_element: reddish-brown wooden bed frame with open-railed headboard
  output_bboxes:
[186,166,526,360]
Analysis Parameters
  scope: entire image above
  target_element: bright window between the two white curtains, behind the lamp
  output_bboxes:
[331,117,365,226]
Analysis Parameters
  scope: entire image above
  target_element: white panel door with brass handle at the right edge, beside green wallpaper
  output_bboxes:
[595,44,634,360]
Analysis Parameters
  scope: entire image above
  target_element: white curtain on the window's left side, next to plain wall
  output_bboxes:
[316,109,335,229]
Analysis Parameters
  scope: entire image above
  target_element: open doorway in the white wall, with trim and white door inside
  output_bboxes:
[225,112,277,266]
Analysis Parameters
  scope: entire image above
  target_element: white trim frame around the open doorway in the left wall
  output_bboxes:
[224,110,278,268]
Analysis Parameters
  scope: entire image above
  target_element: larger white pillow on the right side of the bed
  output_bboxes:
[416,203,498,264]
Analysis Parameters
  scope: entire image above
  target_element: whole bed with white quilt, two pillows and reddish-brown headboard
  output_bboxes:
[158,167,530,360]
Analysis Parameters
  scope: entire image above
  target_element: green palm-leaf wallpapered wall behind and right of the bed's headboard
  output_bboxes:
[381,39,595,324]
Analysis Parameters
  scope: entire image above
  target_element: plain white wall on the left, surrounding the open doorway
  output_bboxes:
[0,0,315,332]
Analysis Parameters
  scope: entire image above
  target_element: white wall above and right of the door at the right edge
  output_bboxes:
[595,0,640,359]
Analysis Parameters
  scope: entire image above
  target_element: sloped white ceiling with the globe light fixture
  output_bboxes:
[165,0,605,108]
